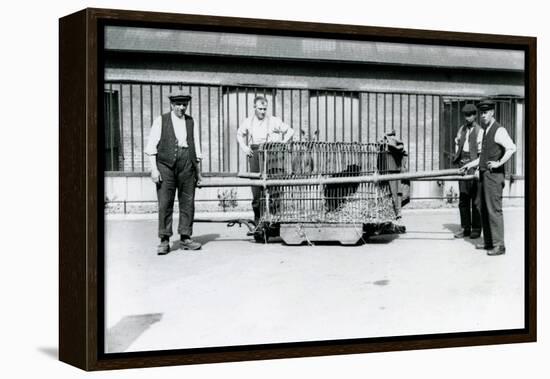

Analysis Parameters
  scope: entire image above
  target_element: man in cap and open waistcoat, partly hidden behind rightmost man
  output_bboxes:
[453,104,483,239]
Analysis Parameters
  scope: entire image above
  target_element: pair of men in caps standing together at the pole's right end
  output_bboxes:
[454,100,516,256]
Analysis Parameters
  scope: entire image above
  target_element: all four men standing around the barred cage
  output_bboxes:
[145,90,516,255]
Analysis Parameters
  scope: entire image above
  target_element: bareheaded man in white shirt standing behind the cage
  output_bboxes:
[237,96,294,226]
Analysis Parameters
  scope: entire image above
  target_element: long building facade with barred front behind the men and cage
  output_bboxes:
[103,27,525,209]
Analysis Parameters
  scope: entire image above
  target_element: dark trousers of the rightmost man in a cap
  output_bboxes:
[479,171,504,247]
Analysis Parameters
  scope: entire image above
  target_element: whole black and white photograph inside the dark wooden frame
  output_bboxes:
[100,25,528,355]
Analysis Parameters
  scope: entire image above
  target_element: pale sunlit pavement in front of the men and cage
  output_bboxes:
[105,208,524,352]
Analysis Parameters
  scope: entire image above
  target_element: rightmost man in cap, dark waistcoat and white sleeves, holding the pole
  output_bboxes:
[462,100,516,256]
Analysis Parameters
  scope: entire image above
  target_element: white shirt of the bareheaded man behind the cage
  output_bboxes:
[237,114,292,145]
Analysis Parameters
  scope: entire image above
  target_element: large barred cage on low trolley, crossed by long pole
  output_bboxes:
[260,142,401,224]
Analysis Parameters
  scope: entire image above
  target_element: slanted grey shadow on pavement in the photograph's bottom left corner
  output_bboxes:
[105,313,162,353]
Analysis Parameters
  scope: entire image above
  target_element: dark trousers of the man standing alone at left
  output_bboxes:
[157,148,196,238]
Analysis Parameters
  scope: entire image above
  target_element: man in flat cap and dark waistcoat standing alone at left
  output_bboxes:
[145,90,205,255]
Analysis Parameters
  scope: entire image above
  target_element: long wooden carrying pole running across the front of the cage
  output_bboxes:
[199,169,464,188]
